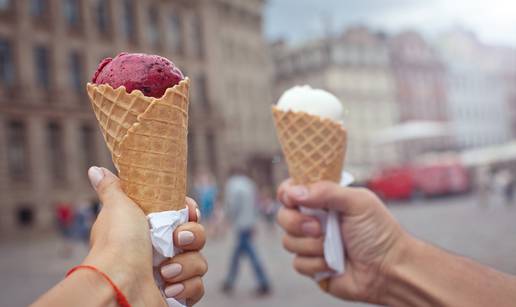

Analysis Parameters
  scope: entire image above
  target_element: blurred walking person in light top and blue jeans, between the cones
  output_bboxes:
[223,167,270,295]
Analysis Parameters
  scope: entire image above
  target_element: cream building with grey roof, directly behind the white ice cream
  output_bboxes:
[271,27,399,180]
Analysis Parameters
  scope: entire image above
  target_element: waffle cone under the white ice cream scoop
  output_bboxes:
[272,107,347,184]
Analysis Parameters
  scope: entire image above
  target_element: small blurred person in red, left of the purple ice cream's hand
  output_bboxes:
[55,202,74,258]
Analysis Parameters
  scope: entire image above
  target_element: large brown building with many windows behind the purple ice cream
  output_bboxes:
[0,0,278,231]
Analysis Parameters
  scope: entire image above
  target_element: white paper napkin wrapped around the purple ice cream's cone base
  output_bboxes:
[147,208,188,307]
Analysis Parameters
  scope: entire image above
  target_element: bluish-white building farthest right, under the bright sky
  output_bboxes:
[435,29,514,150]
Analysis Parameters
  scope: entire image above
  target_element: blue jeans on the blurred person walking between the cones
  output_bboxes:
[226,229,269,287]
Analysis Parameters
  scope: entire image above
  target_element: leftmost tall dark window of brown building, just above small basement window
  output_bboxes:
[7,121,29,181]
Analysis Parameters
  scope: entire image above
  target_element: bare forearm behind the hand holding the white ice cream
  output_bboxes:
[382,239,516,307]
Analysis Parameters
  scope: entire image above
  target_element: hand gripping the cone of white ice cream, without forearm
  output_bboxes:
[278,180,409,303]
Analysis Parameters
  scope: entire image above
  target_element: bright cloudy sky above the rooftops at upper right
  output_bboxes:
[265,0,516,47]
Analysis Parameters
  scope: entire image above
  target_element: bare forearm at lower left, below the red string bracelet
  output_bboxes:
[32,270,118,307]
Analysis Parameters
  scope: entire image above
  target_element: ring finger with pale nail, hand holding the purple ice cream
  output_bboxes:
[161,252,208,284]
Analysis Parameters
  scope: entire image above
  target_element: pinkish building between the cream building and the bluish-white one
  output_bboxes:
[389,31,453,159]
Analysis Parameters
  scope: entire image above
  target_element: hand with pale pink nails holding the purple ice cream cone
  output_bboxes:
[84,167,207,306]
